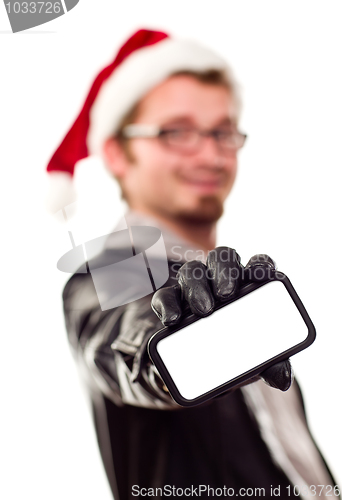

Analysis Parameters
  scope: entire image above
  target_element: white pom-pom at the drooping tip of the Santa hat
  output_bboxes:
[45,171,77,213]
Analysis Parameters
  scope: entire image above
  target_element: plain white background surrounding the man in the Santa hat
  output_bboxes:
[0,0,342,500]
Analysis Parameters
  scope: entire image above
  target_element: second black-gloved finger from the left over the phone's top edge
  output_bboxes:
[177,260,215,317]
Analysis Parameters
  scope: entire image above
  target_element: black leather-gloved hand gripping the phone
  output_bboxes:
[151,247,292,391]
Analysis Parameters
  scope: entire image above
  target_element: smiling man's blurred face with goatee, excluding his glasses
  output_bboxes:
[111,75,237,223]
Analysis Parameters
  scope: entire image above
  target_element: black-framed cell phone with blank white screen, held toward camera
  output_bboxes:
[148,271,316,406]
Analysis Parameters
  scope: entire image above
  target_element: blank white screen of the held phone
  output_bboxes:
[157,281,308,400]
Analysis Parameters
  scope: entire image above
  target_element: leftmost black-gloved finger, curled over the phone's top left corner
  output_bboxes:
[151,285,182,326]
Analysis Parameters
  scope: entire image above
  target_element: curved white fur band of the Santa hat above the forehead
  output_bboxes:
[87,38,233,154]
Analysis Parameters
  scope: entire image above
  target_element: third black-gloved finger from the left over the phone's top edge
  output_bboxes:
[207,247,243,300]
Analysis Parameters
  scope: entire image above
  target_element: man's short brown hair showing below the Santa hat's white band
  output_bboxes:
[109,69,239,200]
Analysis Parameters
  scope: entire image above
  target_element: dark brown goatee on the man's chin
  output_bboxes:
[177,196,223,224]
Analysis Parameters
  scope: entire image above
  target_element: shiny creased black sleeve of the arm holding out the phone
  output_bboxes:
[63,274,180,409]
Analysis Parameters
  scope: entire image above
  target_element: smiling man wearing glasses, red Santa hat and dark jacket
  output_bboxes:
[49,30,334,500]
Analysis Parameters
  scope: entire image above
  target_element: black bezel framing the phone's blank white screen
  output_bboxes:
[147,271,316,406]
